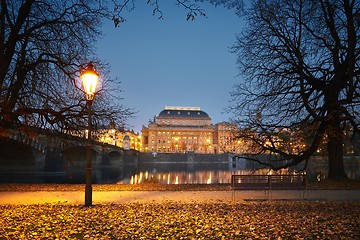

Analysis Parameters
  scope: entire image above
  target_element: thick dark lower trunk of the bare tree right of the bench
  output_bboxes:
[327,119,347,180]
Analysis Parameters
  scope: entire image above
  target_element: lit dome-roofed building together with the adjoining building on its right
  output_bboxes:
[142,106,250,153]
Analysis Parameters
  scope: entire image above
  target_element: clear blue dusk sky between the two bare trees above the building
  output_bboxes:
[97,1,246,132]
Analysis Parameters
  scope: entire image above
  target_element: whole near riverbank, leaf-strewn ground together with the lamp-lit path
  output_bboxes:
[0,182,360,240]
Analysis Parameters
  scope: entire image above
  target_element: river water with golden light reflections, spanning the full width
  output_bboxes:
[0,158,360,184]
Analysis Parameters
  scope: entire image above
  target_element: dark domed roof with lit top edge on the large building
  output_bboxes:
[158,107,210,119]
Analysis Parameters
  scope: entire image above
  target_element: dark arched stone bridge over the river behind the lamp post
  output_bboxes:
[0,129,137,174]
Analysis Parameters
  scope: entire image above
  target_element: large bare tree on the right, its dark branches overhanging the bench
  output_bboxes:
[230,0,360,179]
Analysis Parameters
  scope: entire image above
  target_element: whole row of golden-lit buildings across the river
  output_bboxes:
[67,106,251,154]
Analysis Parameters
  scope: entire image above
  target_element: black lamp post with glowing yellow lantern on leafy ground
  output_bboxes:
[80,63,99,207]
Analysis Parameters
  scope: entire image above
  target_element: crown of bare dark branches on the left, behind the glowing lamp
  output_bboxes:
[0,0,133,135]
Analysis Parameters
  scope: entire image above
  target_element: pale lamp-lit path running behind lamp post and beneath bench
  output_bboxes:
[0,190,360,205]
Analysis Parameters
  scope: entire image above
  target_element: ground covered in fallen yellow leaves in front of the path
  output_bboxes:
[0,201,360,240]
